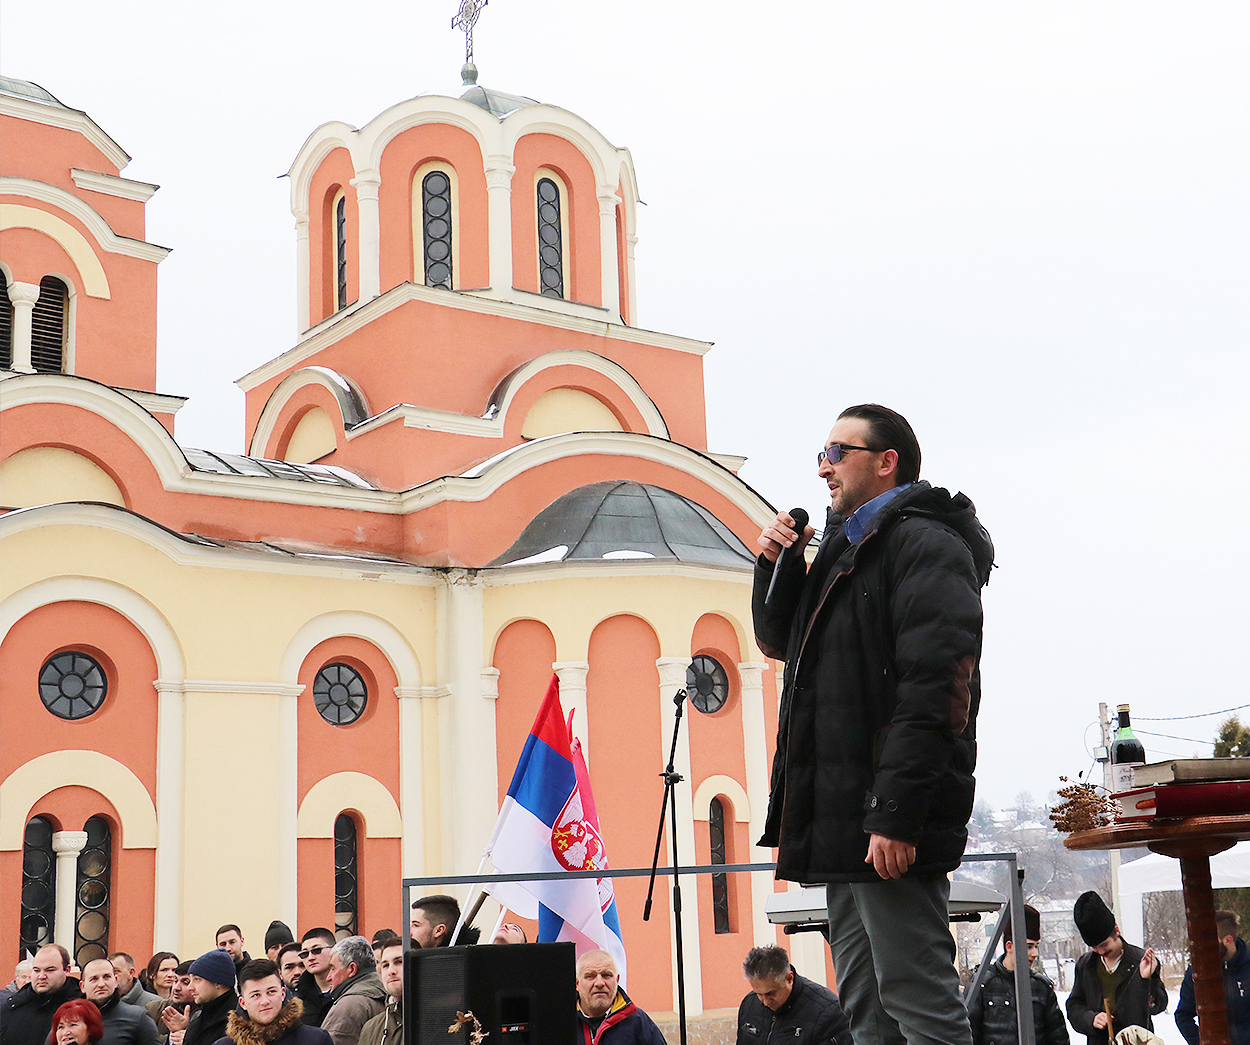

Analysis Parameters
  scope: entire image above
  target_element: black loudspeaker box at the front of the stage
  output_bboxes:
[404,944,578,1045]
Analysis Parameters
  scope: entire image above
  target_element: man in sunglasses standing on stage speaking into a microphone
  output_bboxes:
[751,404,994,1045]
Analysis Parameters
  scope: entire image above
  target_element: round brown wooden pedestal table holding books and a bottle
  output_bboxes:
[1064,814,1250,1045]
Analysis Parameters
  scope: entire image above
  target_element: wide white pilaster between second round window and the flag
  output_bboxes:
[439,569,499,874]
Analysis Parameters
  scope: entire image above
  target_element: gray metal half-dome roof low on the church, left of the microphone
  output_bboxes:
[489,480,755,569]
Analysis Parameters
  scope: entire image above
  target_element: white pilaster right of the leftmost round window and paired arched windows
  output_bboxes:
[153,679,186,946]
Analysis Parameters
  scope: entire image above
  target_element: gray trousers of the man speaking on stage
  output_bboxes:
[829,875,973,1045]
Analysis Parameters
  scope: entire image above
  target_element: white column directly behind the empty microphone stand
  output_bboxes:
[655,656,703,1016]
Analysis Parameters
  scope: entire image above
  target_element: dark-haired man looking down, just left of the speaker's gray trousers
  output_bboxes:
[738,944,851,1045]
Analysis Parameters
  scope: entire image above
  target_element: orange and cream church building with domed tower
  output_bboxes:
[0,65,826,1018]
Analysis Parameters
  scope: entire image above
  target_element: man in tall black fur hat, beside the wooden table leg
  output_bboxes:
[1068,891,1168,1045]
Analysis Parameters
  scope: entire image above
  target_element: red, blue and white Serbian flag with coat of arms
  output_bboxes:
[486,675,625,985]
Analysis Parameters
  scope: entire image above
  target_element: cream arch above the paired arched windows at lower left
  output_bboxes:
[0,750,158,853]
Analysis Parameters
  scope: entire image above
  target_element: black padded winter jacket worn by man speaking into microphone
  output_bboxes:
[751,481,994,883]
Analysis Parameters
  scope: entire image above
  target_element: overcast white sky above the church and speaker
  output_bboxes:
[0,0,1250,805]
